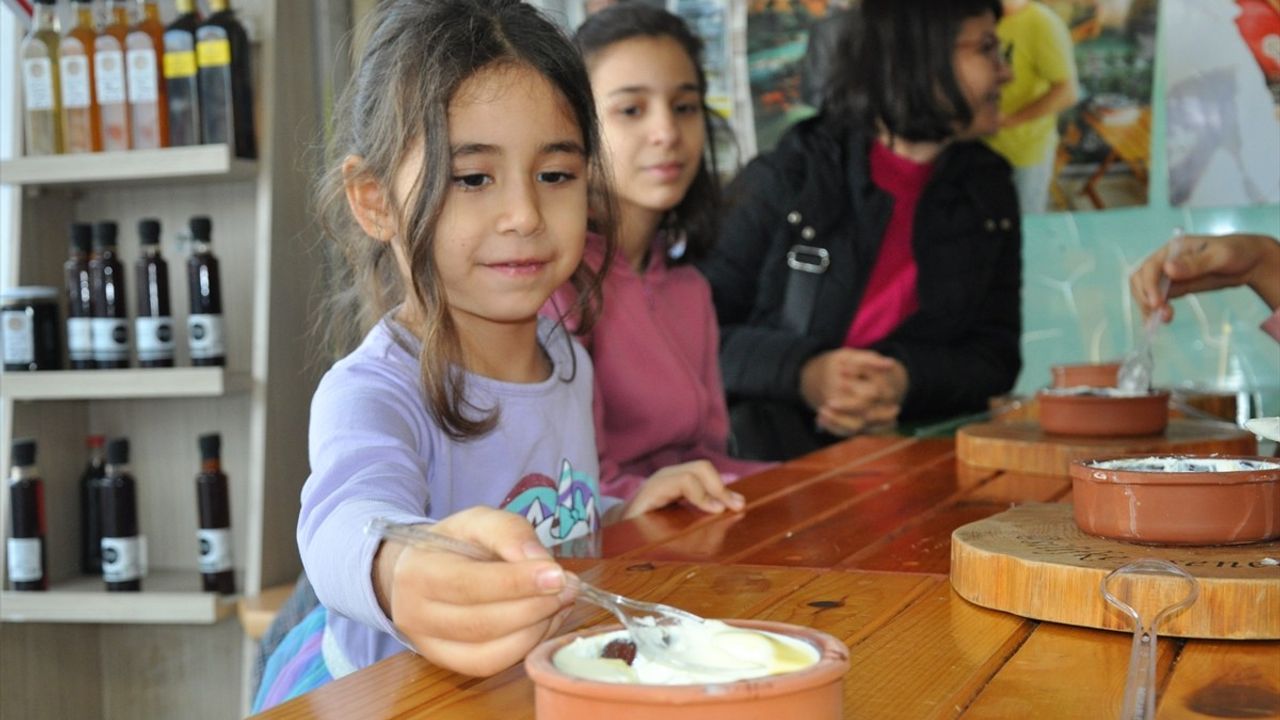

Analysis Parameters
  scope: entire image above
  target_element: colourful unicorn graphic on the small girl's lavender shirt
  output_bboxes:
[502,460,600,546]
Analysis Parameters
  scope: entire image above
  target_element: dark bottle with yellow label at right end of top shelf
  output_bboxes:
[196,0,257,158]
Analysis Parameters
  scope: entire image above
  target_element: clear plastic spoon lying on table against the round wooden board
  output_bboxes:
[1100,557,1199,720]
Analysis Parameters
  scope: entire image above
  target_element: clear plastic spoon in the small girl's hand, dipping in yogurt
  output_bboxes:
[365,518,758,673]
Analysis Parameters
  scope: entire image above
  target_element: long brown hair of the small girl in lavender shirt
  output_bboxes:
[317,0,614,439]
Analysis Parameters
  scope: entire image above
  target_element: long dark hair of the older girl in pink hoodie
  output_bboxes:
[573,3,721,265]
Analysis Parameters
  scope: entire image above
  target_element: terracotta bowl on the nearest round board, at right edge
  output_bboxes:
[1071,455,1280,544]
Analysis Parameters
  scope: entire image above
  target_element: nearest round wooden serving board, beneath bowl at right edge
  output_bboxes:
[951,503,1280,639]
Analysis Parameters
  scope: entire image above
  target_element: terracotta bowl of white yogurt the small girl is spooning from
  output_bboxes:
[525,620,849,720]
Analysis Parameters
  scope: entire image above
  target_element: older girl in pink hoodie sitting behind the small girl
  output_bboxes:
[544,3,765,498]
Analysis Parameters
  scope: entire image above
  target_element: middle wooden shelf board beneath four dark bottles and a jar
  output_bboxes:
[0,368,251,400]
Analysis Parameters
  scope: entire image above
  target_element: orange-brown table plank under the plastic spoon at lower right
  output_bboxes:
[964,623,1181,720]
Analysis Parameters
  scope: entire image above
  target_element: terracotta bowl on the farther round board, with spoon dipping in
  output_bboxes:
[1036,389,1169,437]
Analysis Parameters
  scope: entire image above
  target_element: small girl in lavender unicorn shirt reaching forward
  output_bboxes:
[255,0,730,708]
